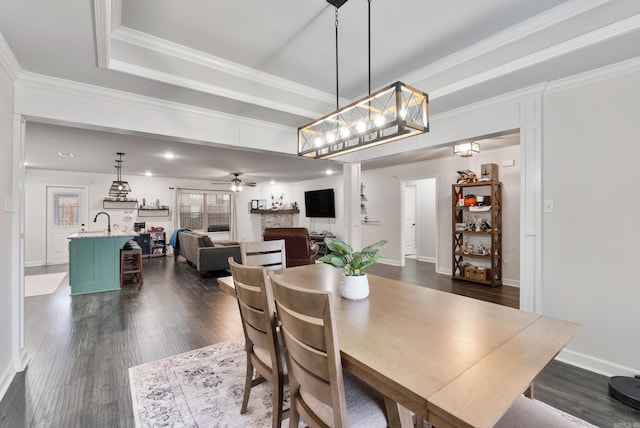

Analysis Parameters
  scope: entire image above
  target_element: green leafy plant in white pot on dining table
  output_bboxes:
[318,238,387,300]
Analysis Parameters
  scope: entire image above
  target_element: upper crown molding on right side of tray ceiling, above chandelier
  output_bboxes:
[400,0,610,87]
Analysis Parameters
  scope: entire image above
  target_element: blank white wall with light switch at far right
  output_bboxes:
[543,68,640,375]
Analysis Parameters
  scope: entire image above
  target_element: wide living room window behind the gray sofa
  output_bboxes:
[178,189,232,232]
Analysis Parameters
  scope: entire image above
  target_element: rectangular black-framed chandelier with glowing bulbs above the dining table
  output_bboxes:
[298,82,429,159]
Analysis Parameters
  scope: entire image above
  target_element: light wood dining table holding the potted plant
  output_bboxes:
[218,264,579,428]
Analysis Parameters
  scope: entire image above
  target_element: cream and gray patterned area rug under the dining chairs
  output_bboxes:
[129,339,596,428]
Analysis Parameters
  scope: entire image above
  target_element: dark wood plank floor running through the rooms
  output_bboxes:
[0,257,640,428]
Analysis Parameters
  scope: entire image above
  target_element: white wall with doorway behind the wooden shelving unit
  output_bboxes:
[362,146,520,285]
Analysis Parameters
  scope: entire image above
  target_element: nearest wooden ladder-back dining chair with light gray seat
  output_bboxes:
[269,272,388,428]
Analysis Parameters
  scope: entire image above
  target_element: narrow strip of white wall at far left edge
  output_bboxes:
[0,41,18,398]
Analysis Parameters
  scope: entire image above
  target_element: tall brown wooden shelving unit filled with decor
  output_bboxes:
[451,181,502,287]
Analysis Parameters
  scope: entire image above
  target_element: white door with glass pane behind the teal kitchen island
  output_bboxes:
[46,187,87,265]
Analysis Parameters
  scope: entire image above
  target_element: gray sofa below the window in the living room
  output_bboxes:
[173,231,241,276]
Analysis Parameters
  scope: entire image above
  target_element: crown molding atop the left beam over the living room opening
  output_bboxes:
[16,72,294,132]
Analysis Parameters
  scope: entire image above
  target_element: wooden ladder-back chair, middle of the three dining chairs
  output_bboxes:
[229,257,289,428]
